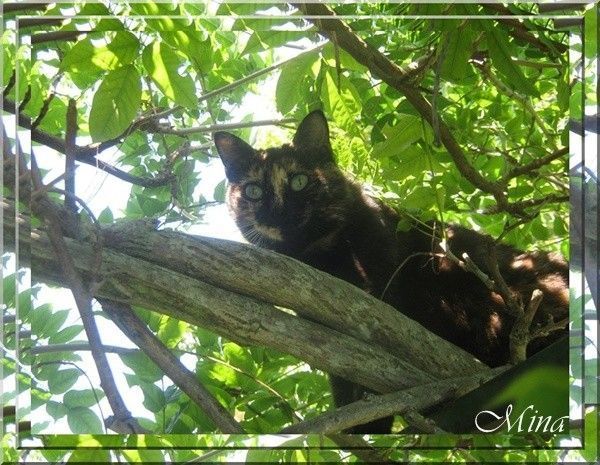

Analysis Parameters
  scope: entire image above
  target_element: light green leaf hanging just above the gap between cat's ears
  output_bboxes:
[275,51,319,114]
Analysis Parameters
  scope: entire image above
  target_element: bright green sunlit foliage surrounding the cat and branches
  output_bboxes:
[2,2,587,462]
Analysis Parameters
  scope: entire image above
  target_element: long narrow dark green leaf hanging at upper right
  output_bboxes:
[481,21,538,96]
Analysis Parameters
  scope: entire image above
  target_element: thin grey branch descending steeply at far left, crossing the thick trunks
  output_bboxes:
[29,151,145,433]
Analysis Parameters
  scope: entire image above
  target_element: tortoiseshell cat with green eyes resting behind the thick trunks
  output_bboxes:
[214,111,569,433]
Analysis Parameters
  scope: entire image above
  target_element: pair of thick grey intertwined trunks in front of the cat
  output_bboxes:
[3,200,489,392]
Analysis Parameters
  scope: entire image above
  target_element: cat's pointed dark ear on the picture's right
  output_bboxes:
[293,110,334,162]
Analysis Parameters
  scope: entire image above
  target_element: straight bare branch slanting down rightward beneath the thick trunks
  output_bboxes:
[98,299,245,434]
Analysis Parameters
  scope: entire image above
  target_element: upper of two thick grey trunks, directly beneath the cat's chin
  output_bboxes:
[106,223,488,376]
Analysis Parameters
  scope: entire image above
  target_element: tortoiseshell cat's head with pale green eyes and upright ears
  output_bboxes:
[214,111,355,252]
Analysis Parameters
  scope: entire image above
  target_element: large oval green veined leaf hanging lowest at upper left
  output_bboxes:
[89,65,142,142]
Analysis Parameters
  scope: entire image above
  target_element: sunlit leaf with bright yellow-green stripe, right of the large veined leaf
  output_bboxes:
[142,42,198,109]
